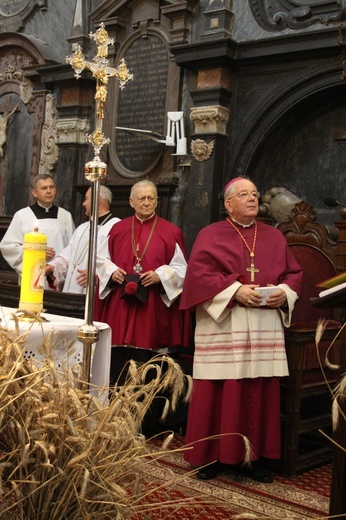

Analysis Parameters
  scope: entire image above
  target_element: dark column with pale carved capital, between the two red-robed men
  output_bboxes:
[181,68,230,249]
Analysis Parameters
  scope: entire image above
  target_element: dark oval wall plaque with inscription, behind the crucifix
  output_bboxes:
[111,34,169,177]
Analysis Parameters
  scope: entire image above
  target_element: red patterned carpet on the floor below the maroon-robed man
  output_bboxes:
[145,435,331,520]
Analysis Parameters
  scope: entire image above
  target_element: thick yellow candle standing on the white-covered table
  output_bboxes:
[19,227,47,312]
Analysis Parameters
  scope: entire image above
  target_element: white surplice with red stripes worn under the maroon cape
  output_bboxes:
[193,282,297,380]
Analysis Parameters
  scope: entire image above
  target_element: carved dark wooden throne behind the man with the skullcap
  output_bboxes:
[278,201,345,477]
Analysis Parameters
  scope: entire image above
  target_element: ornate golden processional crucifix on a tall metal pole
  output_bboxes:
[66,23,133,390]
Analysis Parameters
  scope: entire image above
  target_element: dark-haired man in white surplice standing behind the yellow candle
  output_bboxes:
[0,173,75,277]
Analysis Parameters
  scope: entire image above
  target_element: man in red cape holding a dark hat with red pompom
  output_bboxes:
[94,180,190,434]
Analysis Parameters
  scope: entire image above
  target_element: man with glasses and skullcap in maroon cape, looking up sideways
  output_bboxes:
[181,177,302,483]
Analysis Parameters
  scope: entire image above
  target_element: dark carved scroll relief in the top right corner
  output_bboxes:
[249,0,346,31]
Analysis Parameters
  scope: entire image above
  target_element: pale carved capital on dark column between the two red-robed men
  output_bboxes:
[190,105,230,135]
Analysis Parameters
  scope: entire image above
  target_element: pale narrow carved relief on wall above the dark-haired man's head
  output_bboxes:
[39,94,59,173]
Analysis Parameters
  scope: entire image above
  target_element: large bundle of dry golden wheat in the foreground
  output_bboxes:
[0,321,208,520]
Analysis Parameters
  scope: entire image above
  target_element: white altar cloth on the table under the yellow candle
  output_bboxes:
[0,306,111,400]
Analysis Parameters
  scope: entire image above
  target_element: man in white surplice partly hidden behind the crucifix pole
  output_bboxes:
[46,185,120,294]
